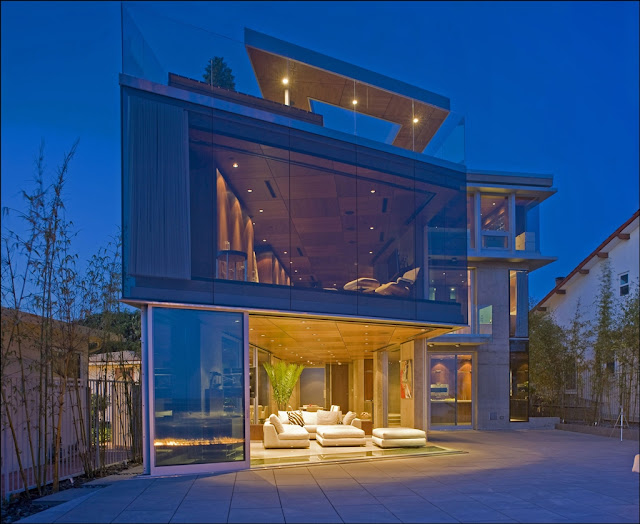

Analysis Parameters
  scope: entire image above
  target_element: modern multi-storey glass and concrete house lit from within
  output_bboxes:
[120,11,555,474]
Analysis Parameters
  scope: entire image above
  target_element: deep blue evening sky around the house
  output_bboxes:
[1,2,639,299]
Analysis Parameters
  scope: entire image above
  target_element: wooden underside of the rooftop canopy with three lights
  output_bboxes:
[247,47,449,152]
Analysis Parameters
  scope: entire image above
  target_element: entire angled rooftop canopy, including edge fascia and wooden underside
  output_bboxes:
[245,30,449,152]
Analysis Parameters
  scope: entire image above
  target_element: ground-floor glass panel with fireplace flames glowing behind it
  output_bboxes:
[152,308,248,467]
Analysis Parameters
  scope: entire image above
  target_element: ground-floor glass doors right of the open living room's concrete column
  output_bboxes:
[429,354,473,427]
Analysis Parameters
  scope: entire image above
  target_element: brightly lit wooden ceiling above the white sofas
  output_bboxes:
[249,315,448,364]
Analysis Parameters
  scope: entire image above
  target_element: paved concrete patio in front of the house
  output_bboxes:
[20,430,640,523]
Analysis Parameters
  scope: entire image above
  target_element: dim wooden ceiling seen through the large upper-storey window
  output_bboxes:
[191,129,446,289]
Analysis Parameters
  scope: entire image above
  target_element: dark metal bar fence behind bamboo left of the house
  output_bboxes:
[1,378,142,497]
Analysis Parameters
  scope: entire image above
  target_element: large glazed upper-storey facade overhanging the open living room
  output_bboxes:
[123,89,468,324]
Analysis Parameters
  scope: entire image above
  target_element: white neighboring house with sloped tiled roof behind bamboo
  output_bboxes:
[534,211,640,419]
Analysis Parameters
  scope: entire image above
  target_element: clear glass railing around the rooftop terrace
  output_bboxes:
[122,2,465,164]
